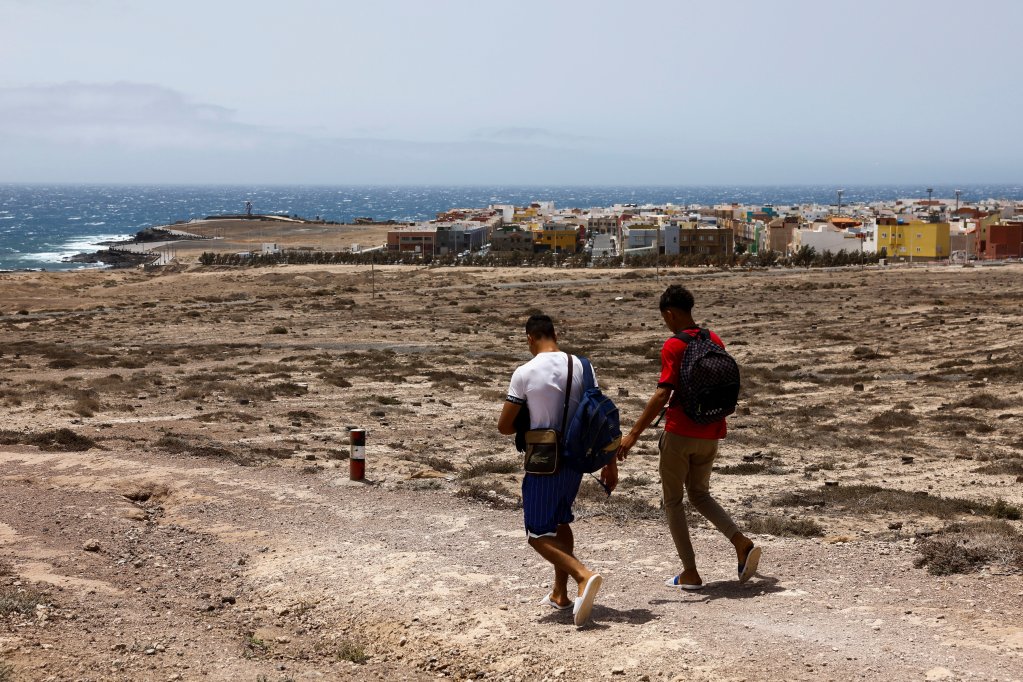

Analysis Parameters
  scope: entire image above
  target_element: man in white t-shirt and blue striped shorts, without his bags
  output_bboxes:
[497,315,618,626]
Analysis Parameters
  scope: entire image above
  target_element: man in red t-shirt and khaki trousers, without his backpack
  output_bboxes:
[618,284,760,590]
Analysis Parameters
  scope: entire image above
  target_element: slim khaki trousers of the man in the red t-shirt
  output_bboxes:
[659,431,739,571]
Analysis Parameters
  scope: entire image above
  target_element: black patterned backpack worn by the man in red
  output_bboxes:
[671,329,740,424]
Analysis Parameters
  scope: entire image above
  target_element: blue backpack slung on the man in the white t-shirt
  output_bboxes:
[564,357,622,473]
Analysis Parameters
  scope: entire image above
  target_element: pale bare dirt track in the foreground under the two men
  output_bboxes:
[0,448,1023,680]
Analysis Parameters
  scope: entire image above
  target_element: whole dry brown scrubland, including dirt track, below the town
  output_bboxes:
[0,258,1023,682]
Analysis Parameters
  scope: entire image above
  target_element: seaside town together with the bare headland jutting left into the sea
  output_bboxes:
[77,191,1023,267]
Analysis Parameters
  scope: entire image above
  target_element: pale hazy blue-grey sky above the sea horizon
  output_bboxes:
[0,0,1023,184]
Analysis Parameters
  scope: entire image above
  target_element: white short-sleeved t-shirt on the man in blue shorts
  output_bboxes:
[507,351,596,429]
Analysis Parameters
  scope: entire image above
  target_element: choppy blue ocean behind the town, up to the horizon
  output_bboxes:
[0,184,1023,270]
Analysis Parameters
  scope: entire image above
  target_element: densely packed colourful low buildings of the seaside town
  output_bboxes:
[387,190,1023,264]
